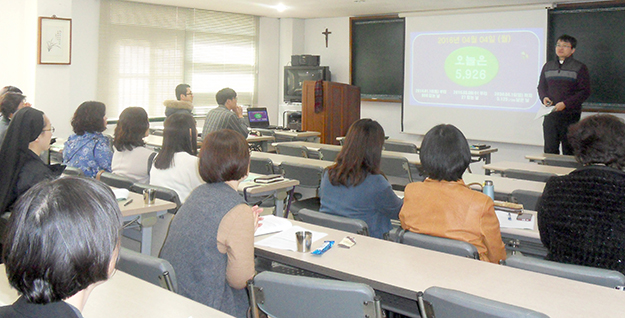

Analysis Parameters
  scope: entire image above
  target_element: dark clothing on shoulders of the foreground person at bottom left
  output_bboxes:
[0,297,83,318]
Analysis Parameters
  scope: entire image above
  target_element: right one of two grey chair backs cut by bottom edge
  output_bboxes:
[417,286,549,318]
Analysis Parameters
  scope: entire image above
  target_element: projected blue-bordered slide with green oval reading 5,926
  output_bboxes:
[410,29,544,112]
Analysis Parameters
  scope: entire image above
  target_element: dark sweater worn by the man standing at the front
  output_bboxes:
[538,56,590,114]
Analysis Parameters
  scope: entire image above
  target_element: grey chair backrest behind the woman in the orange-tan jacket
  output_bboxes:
[397,230,480,260]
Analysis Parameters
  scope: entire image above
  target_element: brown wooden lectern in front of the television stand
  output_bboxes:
[302,81,360,145]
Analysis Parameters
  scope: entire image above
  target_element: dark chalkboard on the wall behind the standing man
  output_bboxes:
[547,6,625,112]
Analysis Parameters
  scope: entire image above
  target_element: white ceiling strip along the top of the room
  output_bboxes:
[133,0,596,19]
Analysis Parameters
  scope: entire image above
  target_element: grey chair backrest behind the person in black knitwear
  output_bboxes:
[505,255,625,288]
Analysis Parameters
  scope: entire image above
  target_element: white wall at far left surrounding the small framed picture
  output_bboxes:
[0,0,100,138]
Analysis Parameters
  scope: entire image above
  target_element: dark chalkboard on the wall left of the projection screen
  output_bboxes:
[351,17,405,102]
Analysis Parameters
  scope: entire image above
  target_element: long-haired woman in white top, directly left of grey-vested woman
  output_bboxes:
[150,113,203,203]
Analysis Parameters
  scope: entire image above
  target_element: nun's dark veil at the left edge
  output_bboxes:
[0,107,45,213]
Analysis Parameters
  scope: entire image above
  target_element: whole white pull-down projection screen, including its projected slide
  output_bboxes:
[402,8,547,145]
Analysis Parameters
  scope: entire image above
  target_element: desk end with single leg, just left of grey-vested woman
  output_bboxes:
[118,192,176,255]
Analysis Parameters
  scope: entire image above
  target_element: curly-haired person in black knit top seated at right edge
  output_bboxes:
[536,115,625,274]
